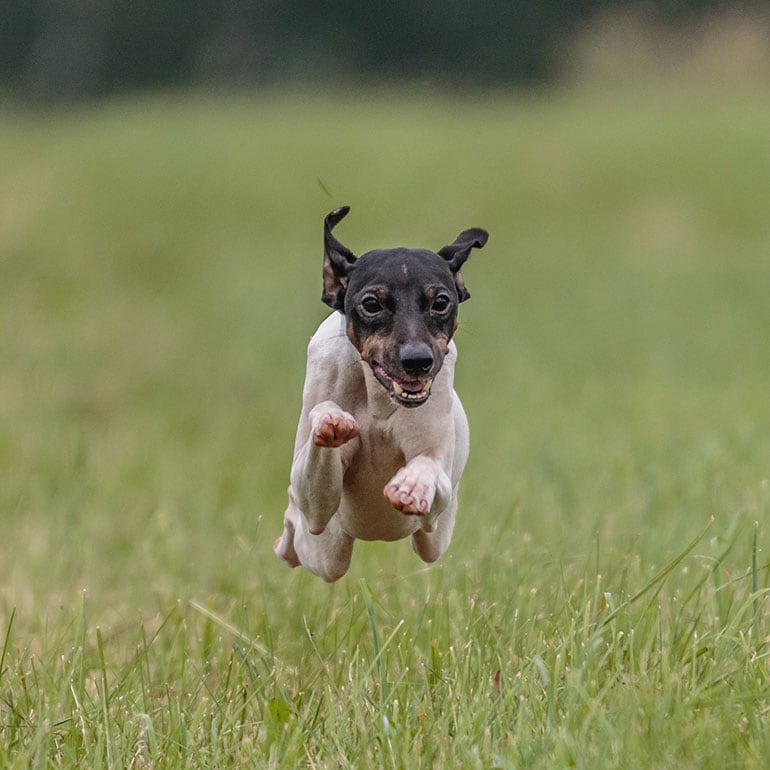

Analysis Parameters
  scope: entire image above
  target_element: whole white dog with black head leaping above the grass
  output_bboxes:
[274,206,489,582]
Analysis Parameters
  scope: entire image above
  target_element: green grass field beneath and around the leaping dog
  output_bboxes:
[0,83,770,770]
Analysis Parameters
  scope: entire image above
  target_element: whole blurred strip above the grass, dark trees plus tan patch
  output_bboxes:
[0,0,768,104]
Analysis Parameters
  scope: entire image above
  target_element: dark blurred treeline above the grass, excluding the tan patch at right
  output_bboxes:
[0,0,730,101]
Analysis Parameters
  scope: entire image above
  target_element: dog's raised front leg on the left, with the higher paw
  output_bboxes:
[291,401,358,535]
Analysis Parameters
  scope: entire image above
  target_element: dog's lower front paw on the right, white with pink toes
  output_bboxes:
[383,455,452,532]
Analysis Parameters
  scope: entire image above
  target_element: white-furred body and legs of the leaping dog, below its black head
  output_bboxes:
[275,312,468,582]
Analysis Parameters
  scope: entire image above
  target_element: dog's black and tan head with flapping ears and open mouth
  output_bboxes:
[322,206,489,406]
